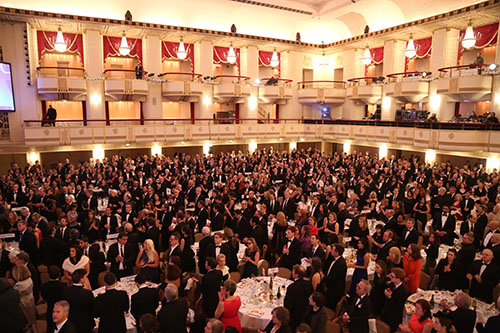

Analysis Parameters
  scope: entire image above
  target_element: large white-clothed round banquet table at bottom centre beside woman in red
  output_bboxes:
[235,276,293,330]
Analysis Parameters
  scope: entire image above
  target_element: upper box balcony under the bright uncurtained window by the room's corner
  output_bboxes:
[298,81,346,104]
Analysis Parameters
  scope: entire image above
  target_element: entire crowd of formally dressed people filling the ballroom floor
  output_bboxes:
[0,148,500,333]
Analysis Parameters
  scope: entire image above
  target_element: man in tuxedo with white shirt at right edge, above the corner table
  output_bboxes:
[467,249,500,303]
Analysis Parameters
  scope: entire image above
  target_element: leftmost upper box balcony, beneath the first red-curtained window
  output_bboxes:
[37,67,87,101]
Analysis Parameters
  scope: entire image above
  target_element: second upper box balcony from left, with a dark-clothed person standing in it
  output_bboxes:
[104,69,148,101]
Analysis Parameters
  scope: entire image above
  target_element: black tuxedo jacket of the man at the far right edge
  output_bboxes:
[469,260,500,303]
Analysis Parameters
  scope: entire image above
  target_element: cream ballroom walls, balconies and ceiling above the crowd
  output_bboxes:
[0,0,500,172]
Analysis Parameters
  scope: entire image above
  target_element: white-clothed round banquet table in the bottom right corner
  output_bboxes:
[403,289,500,324]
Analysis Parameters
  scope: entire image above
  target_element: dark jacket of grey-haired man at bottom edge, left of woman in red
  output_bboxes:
[157,298,188,333]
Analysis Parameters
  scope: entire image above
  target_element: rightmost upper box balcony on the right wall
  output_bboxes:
[437,64,492,102]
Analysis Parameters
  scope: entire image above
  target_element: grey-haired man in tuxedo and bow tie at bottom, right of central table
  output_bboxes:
[342,280,372,333]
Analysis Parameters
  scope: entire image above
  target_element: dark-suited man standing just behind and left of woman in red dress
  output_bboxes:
[193,257,222,318]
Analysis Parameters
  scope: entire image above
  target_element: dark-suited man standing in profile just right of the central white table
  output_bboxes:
[323,244,347,310]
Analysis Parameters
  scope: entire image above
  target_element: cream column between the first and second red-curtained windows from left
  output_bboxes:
[83,29,106,126]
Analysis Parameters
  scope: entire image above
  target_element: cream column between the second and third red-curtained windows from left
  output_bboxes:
[143,35,163,125]
